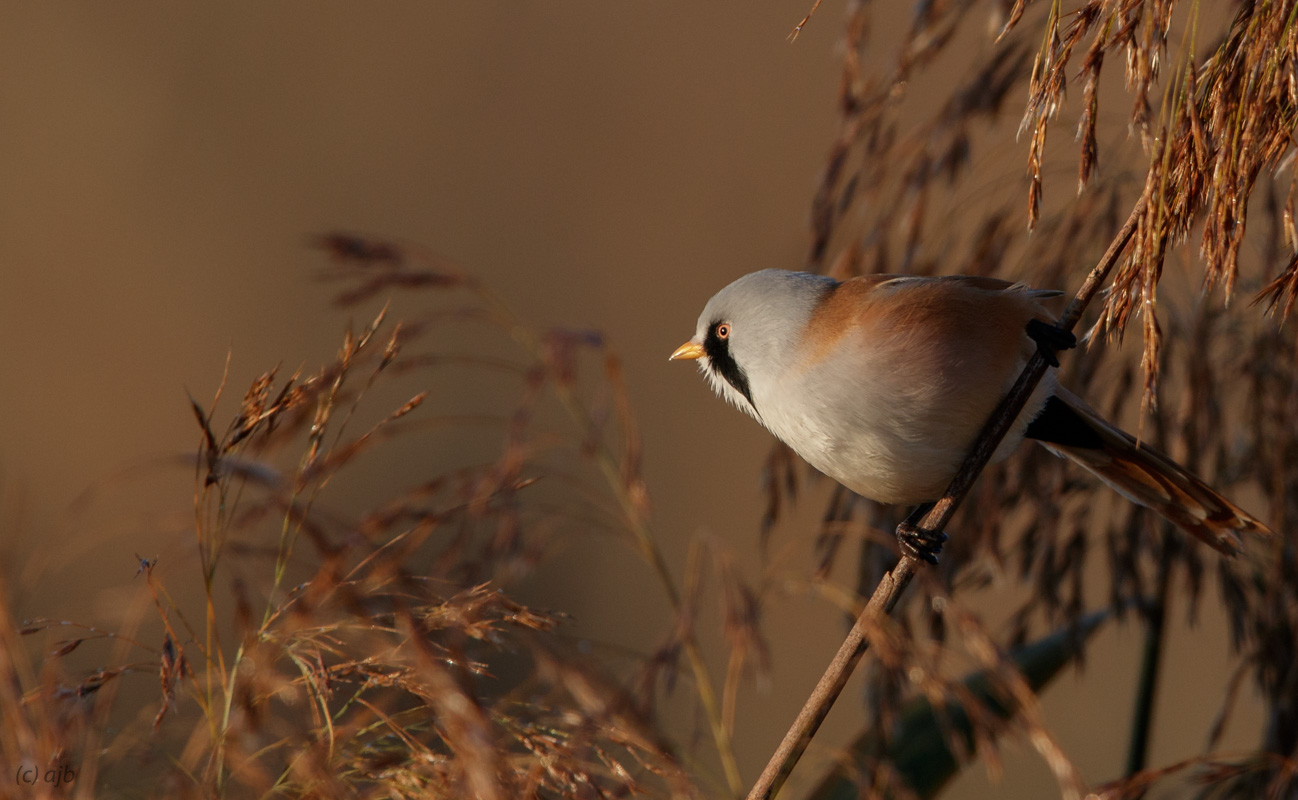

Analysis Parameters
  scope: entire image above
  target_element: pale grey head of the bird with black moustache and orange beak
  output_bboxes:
[671,269,837,421]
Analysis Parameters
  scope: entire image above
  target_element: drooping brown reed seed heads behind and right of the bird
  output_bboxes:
[762,0,1298,796]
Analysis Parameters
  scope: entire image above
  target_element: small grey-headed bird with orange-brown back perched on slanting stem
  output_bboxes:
[670,269,1271,564]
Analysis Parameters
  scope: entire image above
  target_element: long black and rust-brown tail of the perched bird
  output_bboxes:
[1027,388,1271,556]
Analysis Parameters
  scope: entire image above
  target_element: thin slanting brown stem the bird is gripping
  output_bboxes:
[748,195,1145,800]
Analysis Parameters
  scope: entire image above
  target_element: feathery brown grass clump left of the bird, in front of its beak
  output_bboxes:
[0,245,721,799]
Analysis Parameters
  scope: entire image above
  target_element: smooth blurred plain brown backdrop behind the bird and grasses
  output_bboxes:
[0,0,1258,797]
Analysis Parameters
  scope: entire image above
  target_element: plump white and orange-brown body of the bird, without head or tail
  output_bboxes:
[763,271,1053,503]
